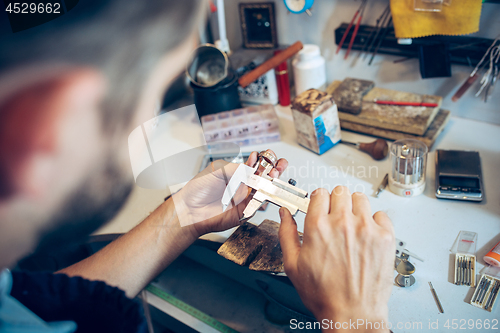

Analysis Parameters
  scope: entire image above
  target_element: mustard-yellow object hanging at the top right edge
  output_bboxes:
[391,0,482,38]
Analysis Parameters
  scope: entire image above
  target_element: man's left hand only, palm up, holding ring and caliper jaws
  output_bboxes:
[172,150,288,238]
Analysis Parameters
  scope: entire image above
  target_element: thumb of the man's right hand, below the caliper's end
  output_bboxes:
[279,207,300,275]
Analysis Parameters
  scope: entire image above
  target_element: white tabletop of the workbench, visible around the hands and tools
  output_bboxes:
[98,107,500,332]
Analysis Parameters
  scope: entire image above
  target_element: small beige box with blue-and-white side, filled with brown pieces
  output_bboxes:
[292,89,340,155]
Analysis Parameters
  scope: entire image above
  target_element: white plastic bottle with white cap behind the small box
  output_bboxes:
[292,44,326,96]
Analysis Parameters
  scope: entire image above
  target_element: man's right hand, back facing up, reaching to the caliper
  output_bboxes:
[279,186,395,332]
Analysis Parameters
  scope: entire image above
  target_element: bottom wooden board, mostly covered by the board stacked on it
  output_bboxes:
[340,109,451,149]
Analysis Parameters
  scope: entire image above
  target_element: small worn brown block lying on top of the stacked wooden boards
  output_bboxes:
[331,78,375,114]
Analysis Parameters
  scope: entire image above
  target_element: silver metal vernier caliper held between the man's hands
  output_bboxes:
[222,151,309,220]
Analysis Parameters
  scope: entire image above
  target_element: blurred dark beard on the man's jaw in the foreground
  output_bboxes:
[33,158,133,256]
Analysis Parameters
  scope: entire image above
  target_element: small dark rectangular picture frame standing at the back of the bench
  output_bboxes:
[239,2,278,49]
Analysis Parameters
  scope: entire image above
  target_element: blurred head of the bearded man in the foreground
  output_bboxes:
[0,0,202,269]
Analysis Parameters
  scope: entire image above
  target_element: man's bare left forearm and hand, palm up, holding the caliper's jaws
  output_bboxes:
[59,151,288,297]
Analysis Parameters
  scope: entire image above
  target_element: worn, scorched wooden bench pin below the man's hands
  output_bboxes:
[217,220,302,273]
